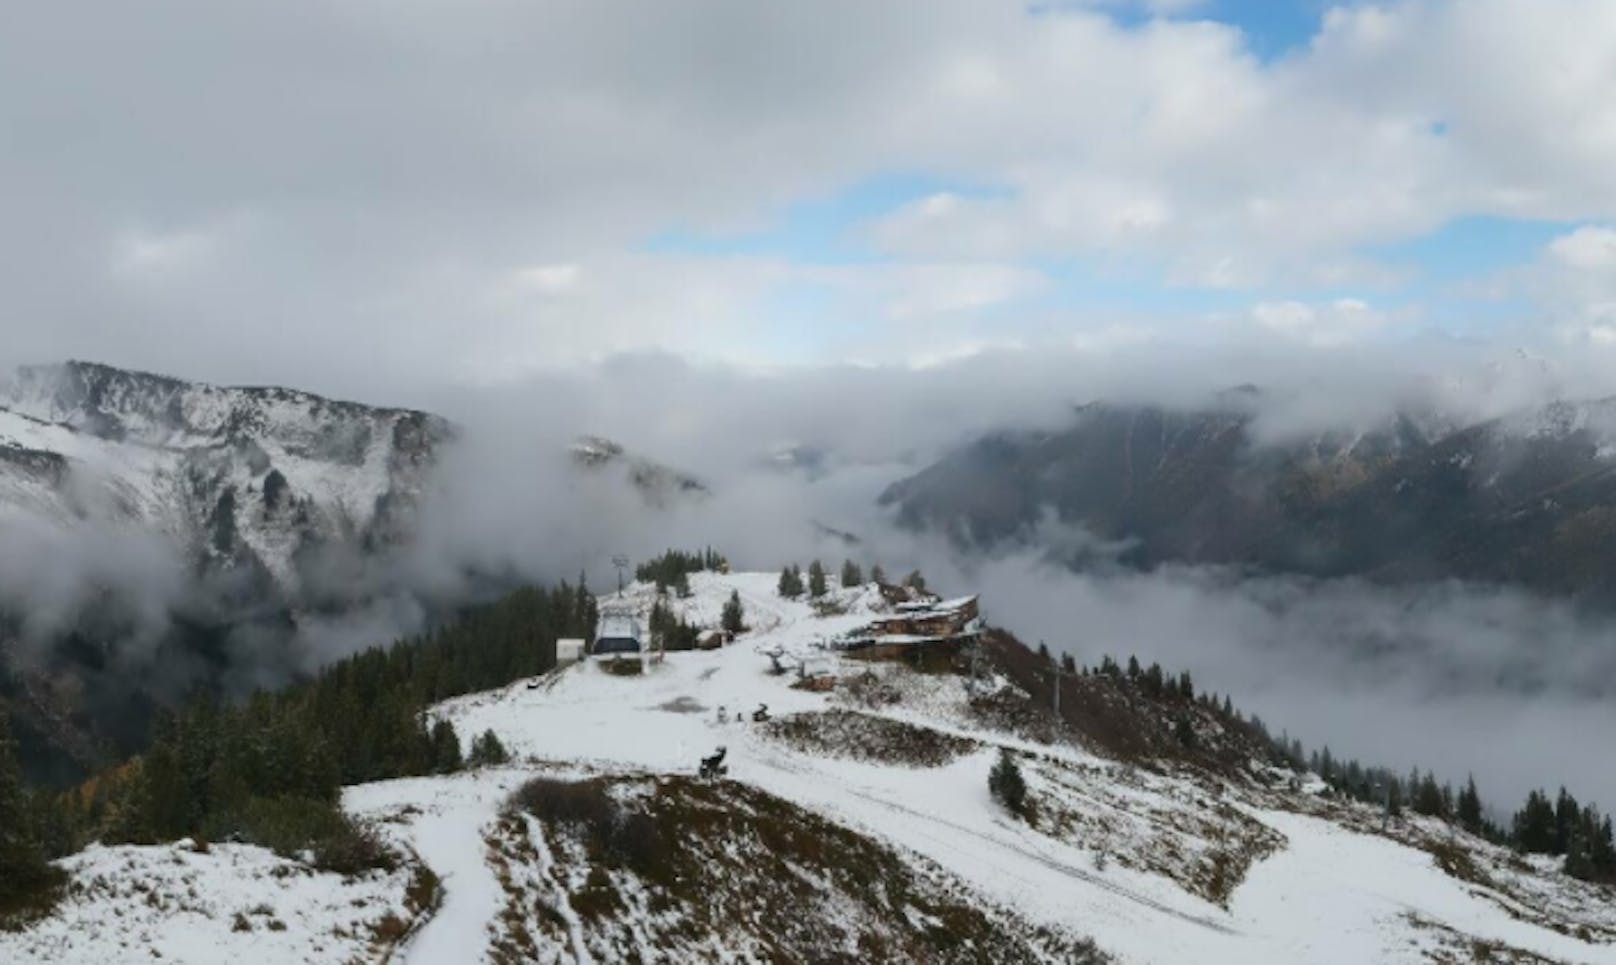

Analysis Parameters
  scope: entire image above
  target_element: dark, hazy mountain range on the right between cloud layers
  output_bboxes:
[881,390,1616,605]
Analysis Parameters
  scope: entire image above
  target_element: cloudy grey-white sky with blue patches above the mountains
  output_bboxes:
[0,0,1616,401]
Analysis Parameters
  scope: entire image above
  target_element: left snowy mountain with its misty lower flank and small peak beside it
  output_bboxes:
[0,362,709,777]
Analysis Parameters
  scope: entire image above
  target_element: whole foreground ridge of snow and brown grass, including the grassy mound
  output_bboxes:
[0,574,1616,962]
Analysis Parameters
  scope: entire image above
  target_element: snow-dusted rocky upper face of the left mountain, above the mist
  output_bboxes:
[0,362,449,595]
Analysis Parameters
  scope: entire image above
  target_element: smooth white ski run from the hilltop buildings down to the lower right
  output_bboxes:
[412,574,1616,962]
